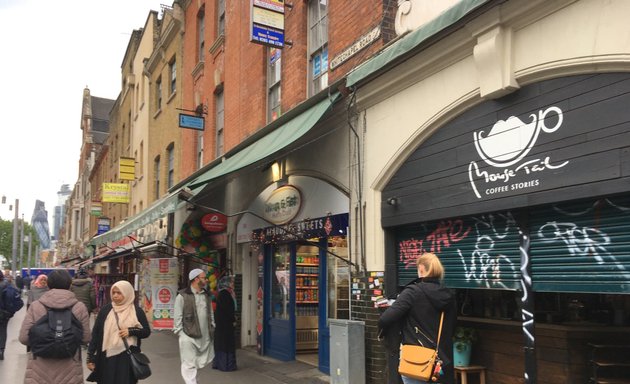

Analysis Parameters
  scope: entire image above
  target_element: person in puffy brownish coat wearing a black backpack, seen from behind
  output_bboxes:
[19,269,91,384]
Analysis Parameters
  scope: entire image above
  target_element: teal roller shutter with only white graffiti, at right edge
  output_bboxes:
[530,196,630,293]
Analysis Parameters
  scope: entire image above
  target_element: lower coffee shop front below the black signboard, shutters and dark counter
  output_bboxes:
[394,194,630,384]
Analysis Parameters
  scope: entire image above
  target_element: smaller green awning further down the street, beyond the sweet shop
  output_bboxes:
[90,190,181,246]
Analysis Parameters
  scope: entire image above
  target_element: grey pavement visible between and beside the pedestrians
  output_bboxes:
[0,296,330,384]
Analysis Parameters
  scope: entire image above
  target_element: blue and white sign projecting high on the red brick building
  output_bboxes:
[250,0,284,48]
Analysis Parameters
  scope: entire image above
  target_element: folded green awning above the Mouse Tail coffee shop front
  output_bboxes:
[346,0,489,87]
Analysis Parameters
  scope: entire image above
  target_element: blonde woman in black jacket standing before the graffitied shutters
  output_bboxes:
[378,253,457,384]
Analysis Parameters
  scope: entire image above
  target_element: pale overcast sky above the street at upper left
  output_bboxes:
[0,0,165,228]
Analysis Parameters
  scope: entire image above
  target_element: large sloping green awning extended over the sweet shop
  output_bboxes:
[188,93,339,189]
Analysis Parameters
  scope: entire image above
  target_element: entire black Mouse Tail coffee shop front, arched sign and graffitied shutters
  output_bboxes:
[381,73,630,384]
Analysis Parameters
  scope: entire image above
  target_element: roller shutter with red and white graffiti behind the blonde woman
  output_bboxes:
[395,212,520,289]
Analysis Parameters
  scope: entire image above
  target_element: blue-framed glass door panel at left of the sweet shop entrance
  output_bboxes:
[264,244,295,361]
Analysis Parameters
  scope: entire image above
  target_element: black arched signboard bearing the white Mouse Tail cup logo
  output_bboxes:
[382,73,630,227]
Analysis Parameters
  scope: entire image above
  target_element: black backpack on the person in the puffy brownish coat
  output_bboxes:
[28,305,83,359]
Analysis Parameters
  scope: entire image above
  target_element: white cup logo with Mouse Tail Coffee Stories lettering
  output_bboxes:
[468,106,569,199]
